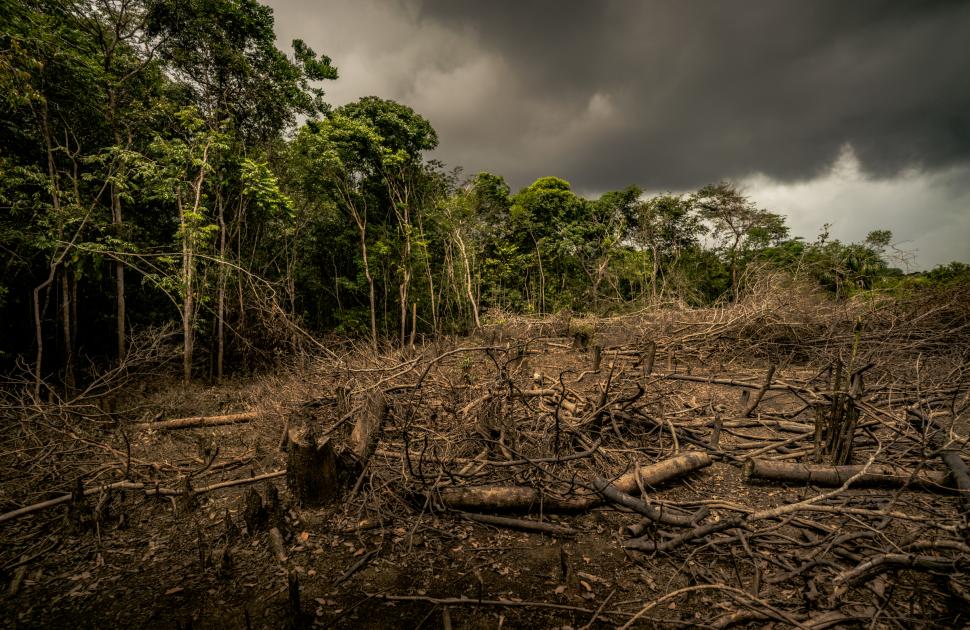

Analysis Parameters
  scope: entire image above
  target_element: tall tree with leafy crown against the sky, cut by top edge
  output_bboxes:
[146,0,337,378]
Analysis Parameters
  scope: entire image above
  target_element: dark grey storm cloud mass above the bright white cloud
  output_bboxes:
[420,0,970,189]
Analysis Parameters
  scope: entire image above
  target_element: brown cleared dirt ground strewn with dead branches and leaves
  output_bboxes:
[0,290,970,629]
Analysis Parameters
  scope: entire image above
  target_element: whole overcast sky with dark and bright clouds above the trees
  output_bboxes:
[268,0,970,270]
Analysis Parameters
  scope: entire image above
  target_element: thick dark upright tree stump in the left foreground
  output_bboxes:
[286,429,339,505]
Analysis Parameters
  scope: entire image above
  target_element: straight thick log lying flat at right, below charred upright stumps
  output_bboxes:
[744,459,949,490]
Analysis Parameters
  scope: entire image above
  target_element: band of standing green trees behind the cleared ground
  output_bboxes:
[0,0,967,393]
